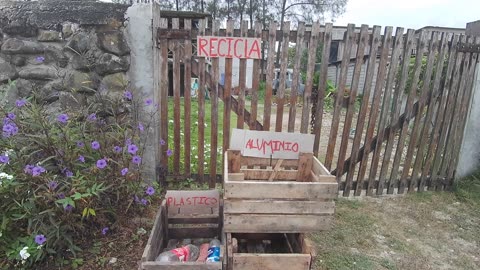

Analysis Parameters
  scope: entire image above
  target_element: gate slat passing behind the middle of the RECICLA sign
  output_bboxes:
[223,20,233,162]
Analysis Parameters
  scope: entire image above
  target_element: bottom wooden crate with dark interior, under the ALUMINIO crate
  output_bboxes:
[226,233,316,270]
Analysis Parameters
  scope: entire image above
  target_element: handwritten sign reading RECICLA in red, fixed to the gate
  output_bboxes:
[197,36,262,59]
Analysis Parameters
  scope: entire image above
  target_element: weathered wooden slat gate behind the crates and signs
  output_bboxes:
[153,5,478,196]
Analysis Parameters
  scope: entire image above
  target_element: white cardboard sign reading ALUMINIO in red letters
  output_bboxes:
[230,129,315,159]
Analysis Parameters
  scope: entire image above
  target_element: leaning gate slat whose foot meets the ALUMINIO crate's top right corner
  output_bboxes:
[325,24,355,170]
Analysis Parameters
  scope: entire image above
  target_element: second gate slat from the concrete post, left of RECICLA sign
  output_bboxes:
[170,18,182,176]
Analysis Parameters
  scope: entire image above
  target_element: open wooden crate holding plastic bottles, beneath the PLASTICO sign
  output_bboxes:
[140,191,225,270]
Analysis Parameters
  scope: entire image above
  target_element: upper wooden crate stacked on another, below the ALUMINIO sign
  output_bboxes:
[223,150,338,233]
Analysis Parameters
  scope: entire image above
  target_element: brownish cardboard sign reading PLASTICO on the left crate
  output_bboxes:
[165,190,220,216]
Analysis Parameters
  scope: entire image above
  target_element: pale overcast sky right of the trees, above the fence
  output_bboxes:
[334,0,480,29]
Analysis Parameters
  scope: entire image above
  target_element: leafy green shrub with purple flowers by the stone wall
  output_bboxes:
[0,87,166,269]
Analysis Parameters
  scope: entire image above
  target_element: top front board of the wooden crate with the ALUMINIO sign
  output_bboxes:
[224,180,338,200]
